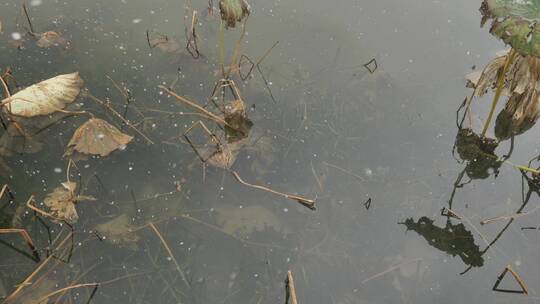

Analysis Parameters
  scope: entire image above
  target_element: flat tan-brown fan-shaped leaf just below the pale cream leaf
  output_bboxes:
[64,118,133,157]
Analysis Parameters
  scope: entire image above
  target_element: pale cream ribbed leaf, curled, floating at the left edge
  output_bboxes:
[2,72,84,117]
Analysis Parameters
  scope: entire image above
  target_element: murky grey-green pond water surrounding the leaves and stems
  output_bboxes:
[0,0,540,304]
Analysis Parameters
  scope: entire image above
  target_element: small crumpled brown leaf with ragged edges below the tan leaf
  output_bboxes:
[43,182,95,223]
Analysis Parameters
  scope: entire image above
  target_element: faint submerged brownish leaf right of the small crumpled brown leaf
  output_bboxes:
[96,214,140,250]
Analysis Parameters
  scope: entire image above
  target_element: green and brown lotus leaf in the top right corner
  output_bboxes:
[480,0,540,57]
